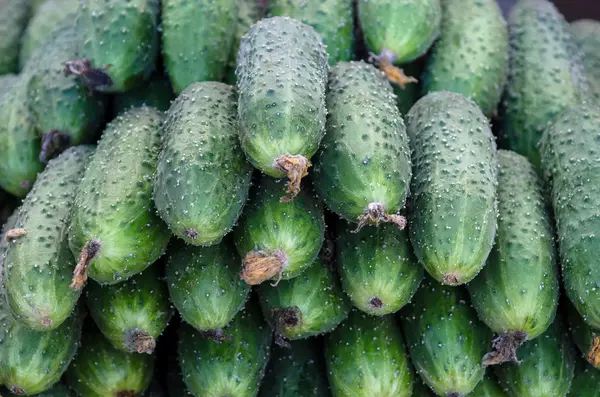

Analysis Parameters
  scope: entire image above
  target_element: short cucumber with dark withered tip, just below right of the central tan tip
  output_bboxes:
[258,259,350,340]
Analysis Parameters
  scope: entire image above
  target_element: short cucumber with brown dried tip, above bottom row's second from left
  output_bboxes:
[86,265,173,354]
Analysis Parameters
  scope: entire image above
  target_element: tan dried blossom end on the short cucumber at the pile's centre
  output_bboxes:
[241,249,287,287]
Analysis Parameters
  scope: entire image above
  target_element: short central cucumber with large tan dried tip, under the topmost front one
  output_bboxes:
[233,176,325,285]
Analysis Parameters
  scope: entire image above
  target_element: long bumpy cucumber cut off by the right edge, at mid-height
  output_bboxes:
[541,106,600,329]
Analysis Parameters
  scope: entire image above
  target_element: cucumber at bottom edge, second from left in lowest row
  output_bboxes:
[66,327,155,397]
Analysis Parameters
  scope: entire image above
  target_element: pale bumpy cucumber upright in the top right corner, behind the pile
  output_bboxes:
[501,0,588,167]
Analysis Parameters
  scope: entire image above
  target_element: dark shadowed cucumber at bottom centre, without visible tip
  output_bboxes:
[258,339,331,397]
